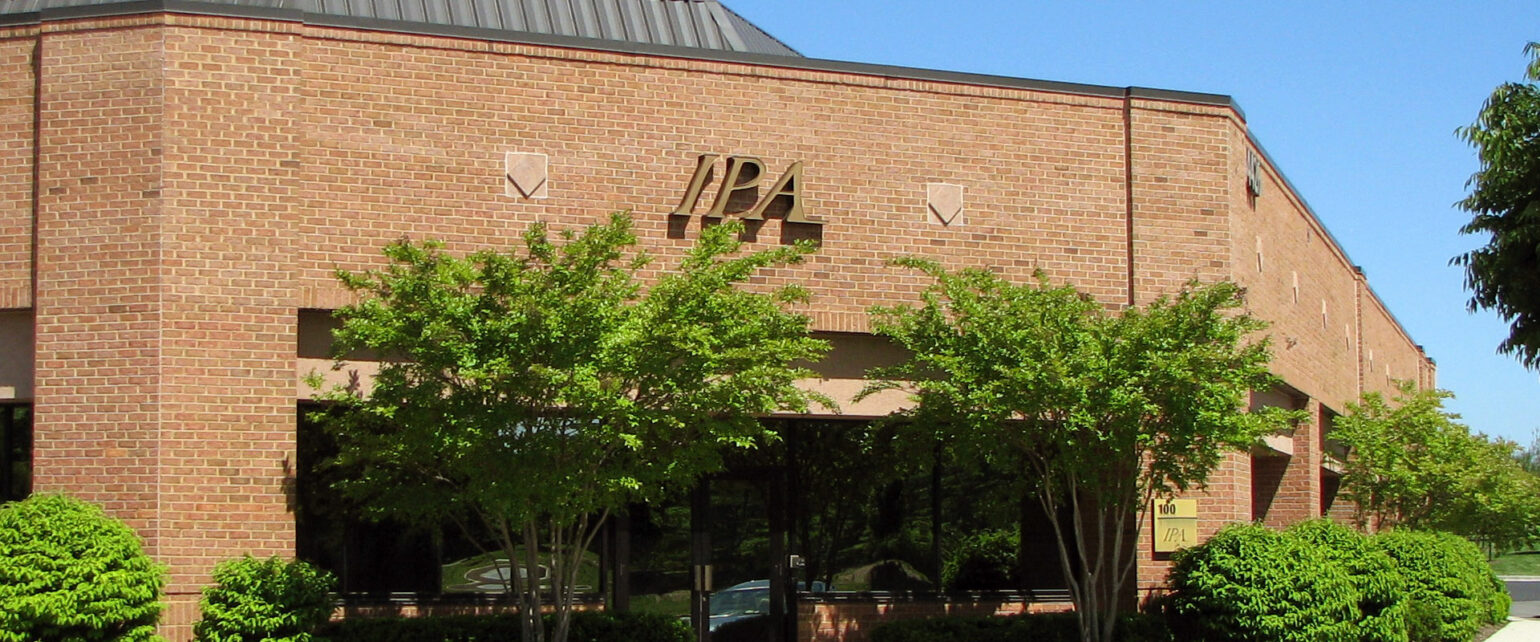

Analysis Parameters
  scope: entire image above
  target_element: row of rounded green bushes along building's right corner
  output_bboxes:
[1164,520,1509,642]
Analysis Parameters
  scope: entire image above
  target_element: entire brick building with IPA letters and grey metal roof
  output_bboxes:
[0,0,1434,639]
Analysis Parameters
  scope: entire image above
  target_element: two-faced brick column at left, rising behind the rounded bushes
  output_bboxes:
[34,15,302,640]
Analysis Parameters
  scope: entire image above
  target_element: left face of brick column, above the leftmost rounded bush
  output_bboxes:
[34,18,166,535]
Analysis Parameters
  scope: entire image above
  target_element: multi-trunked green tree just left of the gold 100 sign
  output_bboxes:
[869,259,1292,642]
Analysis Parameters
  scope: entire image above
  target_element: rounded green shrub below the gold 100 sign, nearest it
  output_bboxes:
[1166,525,1360,642]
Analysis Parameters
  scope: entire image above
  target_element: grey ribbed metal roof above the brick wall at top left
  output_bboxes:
[0,0,801,57]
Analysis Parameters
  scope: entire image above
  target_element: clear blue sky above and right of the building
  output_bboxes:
[724,0,1540,443]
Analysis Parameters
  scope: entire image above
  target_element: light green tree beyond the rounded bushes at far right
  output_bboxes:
[1332,382,1540,548]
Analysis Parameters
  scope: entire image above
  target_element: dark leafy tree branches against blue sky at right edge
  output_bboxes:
[1452,43,1540,368]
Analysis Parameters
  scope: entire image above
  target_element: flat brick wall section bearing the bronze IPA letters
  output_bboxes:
[299,28,1145,320]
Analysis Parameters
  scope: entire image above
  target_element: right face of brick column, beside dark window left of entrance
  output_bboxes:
[159,22,302,634]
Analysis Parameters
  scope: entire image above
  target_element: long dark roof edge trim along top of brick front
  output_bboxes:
[0,0,1244,112]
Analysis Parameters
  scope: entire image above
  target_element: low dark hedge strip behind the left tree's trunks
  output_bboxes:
[317,611,693,642]
